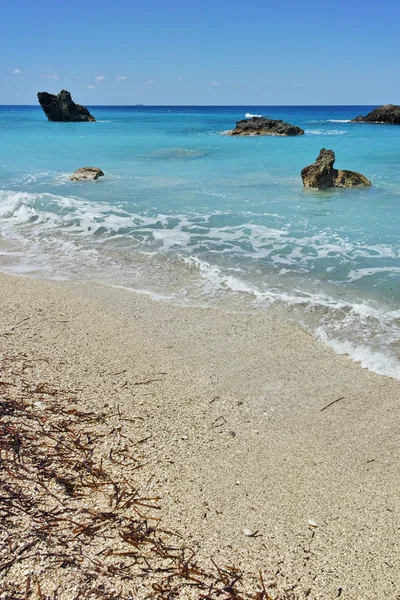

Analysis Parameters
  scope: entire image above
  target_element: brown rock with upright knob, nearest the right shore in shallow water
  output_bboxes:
[301,148,372,189]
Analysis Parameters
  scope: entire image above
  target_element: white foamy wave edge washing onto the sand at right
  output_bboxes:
[181,256,400,379]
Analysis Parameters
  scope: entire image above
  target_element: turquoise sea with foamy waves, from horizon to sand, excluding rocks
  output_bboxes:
[0,106,400,379]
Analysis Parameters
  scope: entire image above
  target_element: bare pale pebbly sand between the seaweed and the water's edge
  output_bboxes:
[0,274,400,600]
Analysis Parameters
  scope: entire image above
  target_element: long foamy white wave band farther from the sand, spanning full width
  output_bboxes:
[0,190,400,274]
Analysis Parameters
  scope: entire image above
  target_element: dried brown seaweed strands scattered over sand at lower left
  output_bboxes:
[0,356,288,600]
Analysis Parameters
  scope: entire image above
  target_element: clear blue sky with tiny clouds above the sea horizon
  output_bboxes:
[0,0,400,105]
